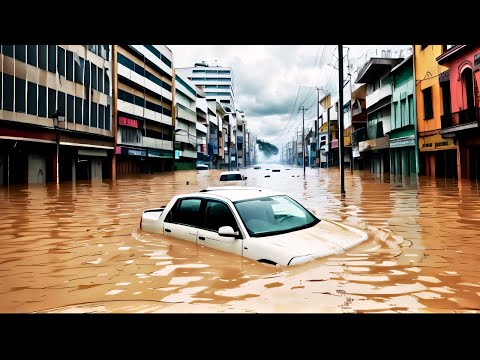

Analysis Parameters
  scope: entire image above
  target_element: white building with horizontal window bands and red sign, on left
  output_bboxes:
[114,45,175,175]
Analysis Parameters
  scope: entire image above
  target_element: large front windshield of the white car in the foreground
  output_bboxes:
[234,195,320,237]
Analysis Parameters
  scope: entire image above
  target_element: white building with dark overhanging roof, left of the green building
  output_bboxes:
[355,58,403,174]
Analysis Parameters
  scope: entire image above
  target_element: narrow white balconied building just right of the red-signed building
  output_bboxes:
[174,74,197,170]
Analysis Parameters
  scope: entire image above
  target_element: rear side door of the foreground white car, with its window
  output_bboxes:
[163,197,202,243]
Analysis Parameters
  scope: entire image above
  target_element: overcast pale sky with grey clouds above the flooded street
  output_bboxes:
[167,45,411,150]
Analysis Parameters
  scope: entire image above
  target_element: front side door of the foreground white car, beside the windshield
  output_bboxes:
[197,199,243,255]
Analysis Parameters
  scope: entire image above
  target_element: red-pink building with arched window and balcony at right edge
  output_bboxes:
[437,45,480,180]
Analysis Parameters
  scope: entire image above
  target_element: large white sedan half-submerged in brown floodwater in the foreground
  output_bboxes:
[140,186,368,266]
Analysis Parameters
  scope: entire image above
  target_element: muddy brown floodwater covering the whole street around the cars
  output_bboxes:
[0,165,480,313]
